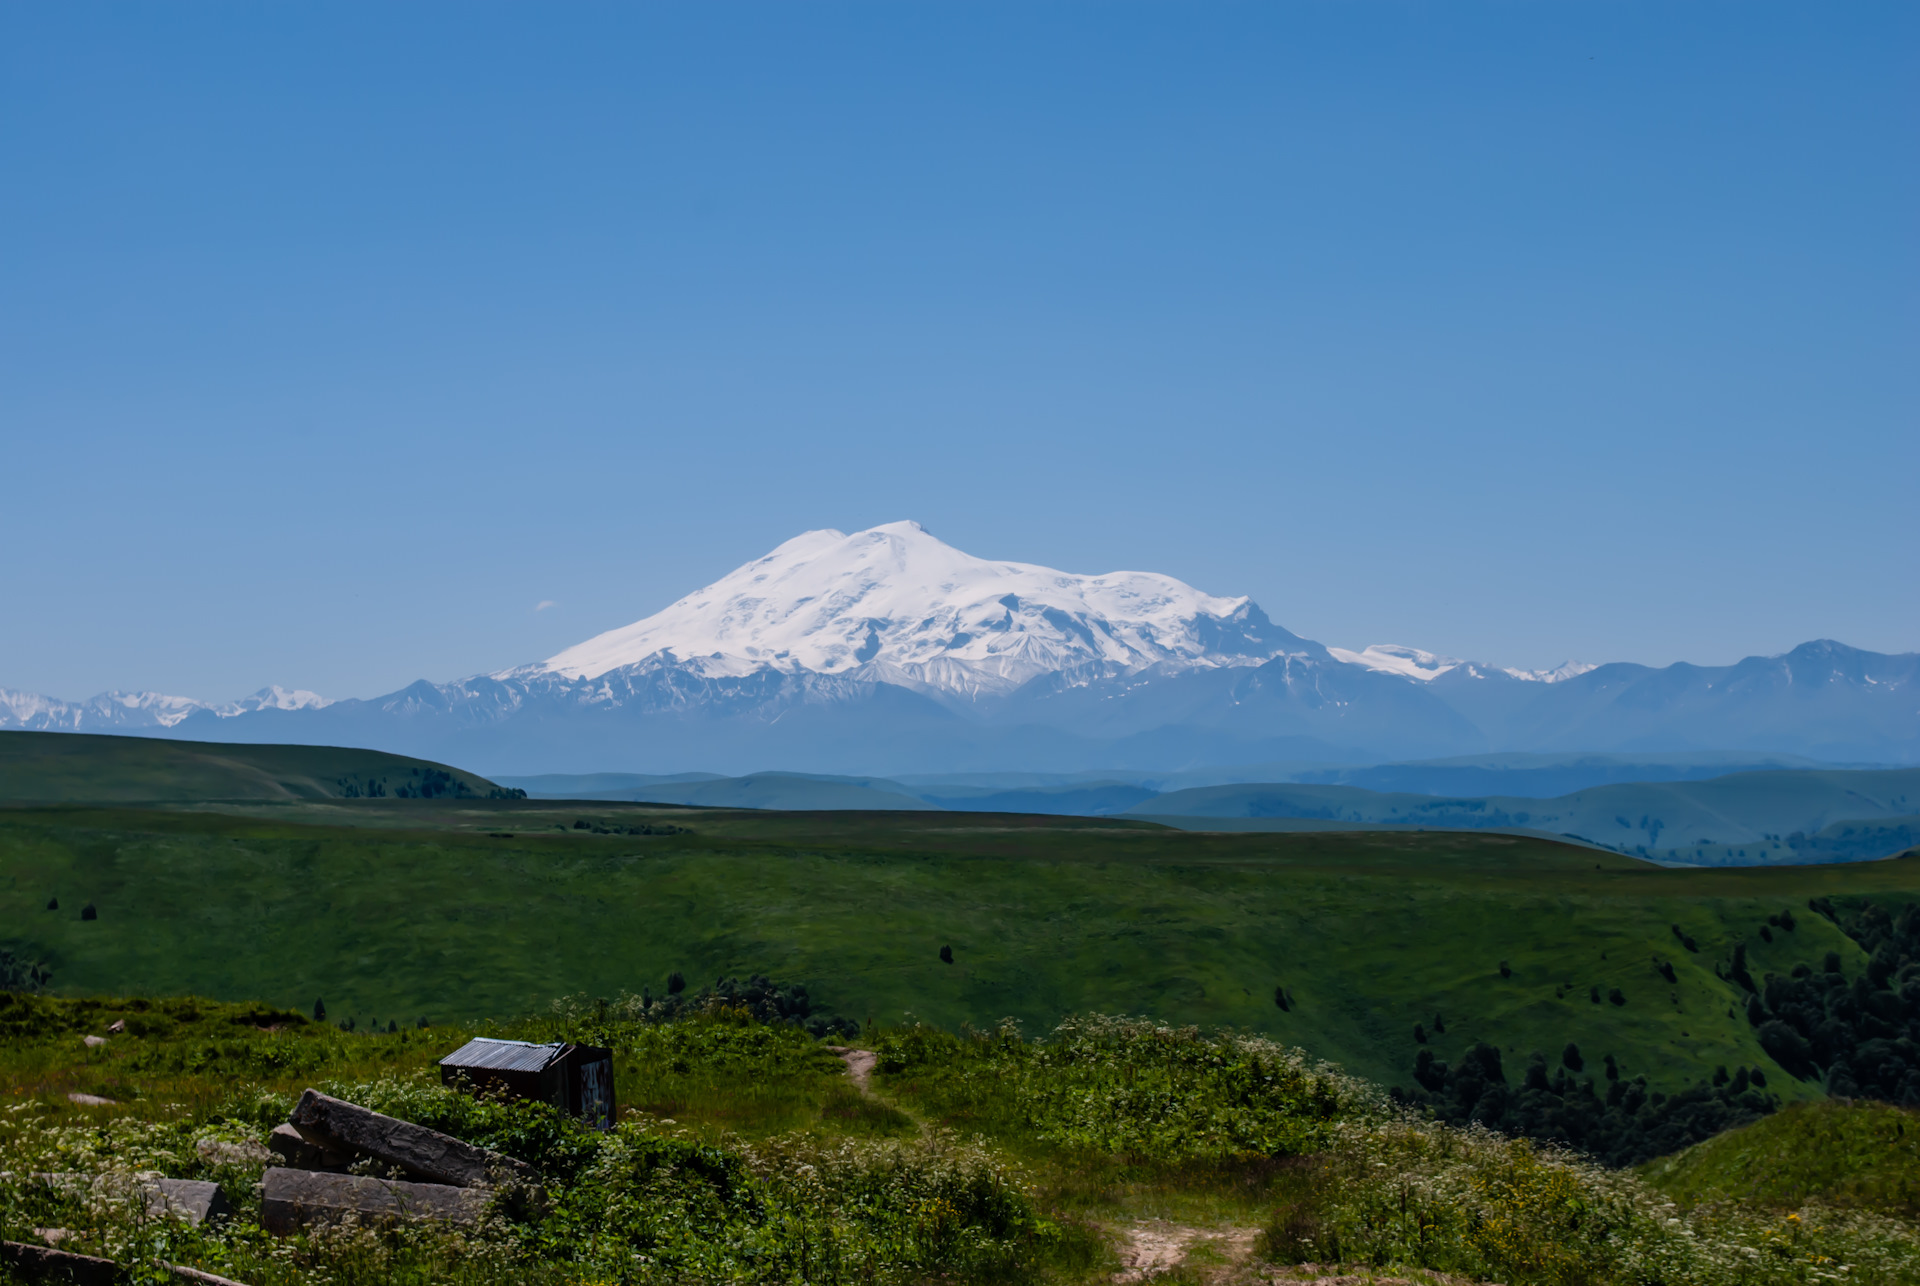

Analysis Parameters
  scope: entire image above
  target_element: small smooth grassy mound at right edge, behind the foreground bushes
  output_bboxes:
[1642,1102,1920,1219]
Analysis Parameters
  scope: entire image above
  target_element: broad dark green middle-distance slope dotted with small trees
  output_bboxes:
[0,800,1920,1096]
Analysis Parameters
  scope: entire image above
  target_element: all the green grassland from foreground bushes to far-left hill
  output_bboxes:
[0,739,1920,1286]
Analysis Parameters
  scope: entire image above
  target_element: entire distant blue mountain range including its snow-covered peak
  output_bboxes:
[0,522,1920,775]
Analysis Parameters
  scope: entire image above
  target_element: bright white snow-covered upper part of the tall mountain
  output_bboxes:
[537,522,1325,697]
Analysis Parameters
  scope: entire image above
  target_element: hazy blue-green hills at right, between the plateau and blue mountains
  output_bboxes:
[1127,768,1920,864]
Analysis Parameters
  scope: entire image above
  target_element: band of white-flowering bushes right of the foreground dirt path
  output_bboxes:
[879,1017,1920,1286]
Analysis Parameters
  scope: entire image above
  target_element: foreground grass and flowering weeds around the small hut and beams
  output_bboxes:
[0,996,1920,1286]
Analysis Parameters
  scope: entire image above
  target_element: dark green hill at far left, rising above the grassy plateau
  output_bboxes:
[0,731,493,804]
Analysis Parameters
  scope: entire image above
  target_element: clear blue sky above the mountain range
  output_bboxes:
[0,0,1920,699]
